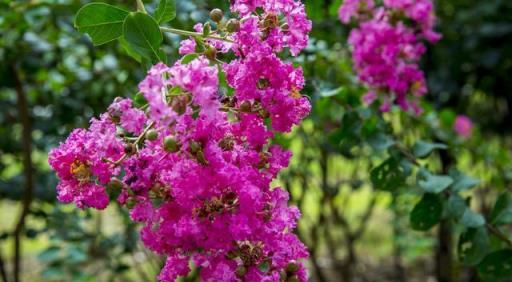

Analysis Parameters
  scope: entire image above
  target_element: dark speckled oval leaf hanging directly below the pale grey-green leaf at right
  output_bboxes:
[410,193,443,231]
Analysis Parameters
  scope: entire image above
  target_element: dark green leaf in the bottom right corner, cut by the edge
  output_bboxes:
[478,249,512,281]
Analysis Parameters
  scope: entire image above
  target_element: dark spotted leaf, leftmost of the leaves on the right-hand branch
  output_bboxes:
[370,158,406,191]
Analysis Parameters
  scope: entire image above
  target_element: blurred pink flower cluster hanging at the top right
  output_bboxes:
[339,0,441,114]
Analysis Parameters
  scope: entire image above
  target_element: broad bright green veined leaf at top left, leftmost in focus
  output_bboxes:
[75,3,129,46]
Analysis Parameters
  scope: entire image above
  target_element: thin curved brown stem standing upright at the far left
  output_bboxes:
[10,63,34,282]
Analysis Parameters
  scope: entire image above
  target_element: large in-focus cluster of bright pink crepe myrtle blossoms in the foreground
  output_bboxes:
[49,0,311,282]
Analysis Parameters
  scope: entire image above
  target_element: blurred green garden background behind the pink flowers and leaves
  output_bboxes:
[0,0,512,281]
